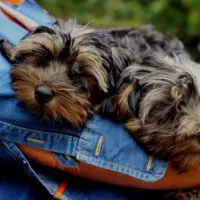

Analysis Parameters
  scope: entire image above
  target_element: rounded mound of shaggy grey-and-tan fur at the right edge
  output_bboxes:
[120,54,200,167]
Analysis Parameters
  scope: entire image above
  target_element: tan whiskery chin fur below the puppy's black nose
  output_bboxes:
[13,82,91,128]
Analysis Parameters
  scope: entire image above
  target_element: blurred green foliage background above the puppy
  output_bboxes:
[37,0,200,61]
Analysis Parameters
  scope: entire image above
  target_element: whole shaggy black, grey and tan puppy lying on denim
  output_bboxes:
[1,20,200,170]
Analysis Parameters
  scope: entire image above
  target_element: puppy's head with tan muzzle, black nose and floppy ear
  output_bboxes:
[12,21,111,127]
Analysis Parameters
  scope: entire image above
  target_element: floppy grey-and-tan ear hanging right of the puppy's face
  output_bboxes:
[69,29,113,93]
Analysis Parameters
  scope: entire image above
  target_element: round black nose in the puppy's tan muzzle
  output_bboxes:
[35,86,53,104]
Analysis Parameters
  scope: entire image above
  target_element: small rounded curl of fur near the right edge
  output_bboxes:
[171,73,195,102]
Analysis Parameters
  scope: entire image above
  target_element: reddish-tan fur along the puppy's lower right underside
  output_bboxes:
[125,118,200,172]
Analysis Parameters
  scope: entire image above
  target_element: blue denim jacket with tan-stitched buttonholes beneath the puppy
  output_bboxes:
[0,0,167,199]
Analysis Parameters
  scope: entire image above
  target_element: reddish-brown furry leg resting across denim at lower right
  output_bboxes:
[125,118,200,173]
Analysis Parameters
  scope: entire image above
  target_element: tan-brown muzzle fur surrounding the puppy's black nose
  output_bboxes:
[12,66,90,128]
